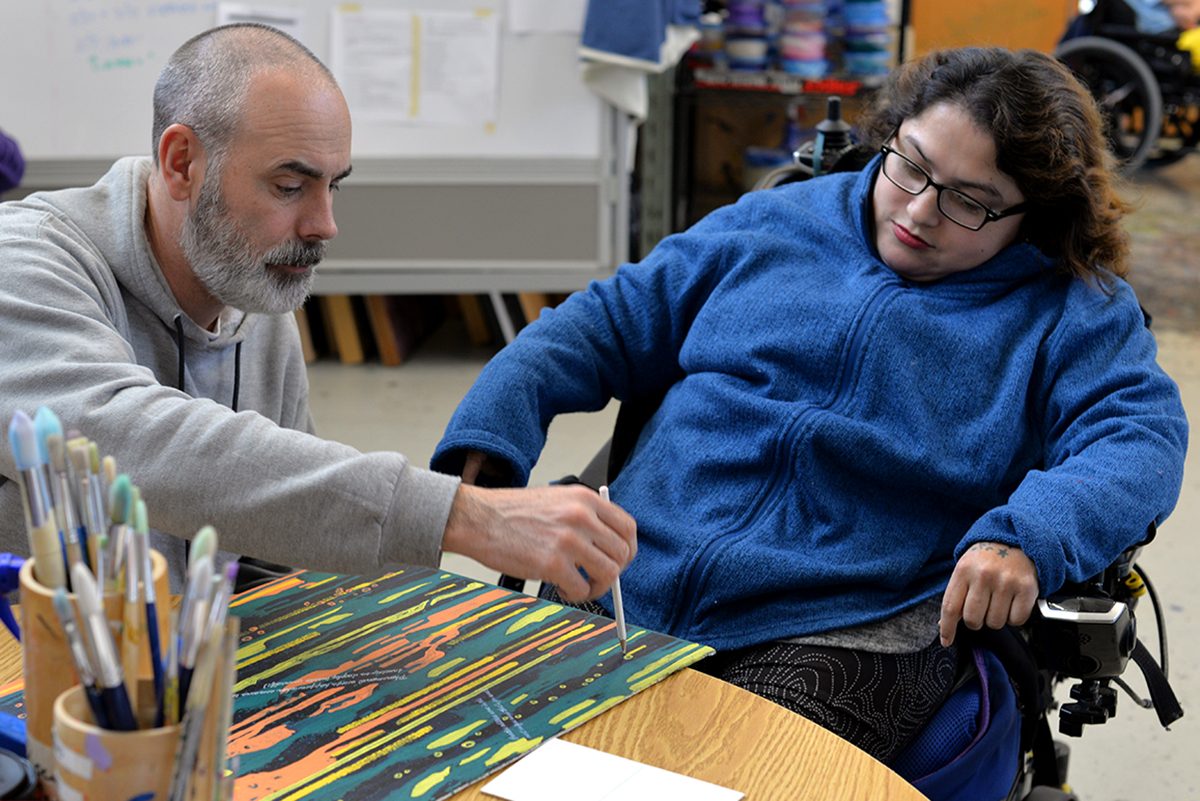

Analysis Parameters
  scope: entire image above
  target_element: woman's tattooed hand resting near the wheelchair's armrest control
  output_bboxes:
[937,542,1038,645]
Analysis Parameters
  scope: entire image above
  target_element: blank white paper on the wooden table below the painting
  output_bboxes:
[482,737,743,801]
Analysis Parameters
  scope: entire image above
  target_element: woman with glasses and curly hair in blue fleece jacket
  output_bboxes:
[434,48,1187,761]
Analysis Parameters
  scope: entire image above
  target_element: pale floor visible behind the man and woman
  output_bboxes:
[302,157,1200,801]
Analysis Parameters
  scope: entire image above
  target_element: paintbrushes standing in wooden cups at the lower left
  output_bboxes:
[8,406,238,801]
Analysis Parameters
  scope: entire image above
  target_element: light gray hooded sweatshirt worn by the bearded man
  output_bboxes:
[0,158,458,589]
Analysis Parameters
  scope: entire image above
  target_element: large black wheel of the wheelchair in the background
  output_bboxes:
[1055,36,1163,171]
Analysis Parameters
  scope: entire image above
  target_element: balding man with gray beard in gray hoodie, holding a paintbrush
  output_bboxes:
[0,24,636,600]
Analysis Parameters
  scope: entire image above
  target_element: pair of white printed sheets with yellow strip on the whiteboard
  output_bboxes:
[330,4,500,125]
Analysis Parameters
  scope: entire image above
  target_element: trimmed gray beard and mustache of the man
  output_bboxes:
[179,173,325,314]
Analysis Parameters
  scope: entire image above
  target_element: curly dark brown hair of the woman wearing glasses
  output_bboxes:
[859,48,1130,283]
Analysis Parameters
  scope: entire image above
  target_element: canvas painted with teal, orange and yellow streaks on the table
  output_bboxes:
[229,567,712,801]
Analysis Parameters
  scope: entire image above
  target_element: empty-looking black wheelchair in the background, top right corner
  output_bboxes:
[1054,0,1200,171]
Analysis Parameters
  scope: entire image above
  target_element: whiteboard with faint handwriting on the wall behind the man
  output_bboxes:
[0,0,607,163]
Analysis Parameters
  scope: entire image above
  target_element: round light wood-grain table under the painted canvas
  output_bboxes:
[0,623,925,801]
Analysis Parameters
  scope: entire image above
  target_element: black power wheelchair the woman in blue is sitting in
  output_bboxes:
[499,110,1183,801]
